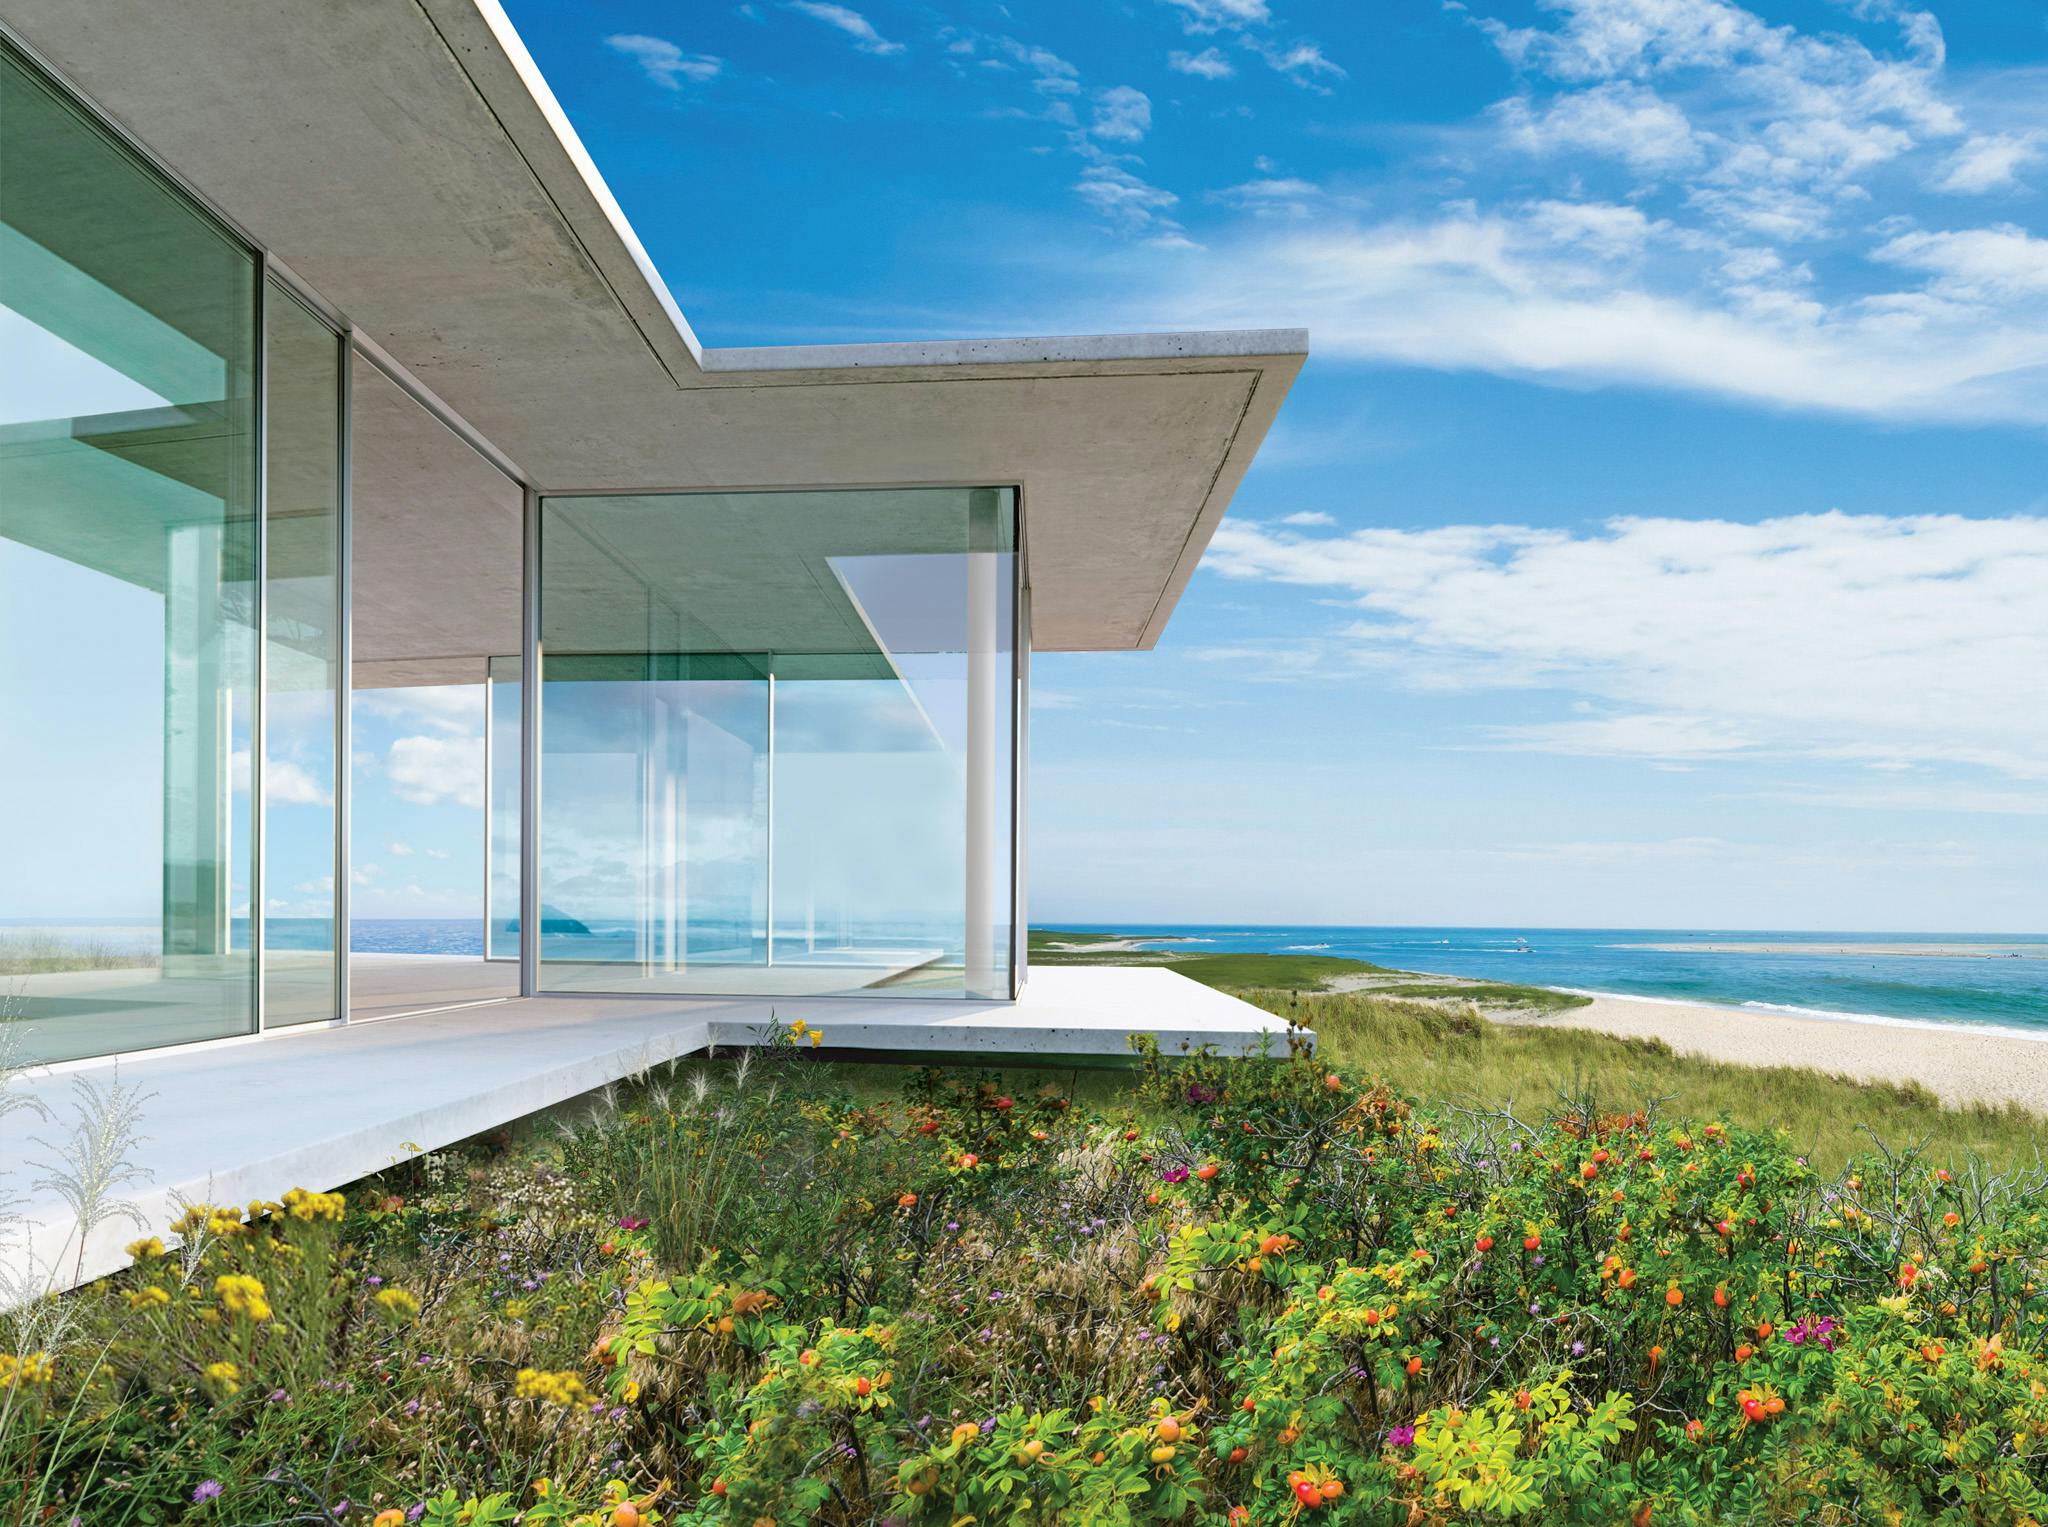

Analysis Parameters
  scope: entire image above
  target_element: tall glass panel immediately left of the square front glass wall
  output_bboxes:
[348,356,526,1019]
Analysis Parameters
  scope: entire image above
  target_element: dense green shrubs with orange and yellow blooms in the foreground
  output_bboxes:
[0,1027,2048,1527]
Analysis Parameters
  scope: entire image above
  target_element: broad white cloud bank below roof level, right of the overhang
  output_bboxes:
[1206,514,2048,790]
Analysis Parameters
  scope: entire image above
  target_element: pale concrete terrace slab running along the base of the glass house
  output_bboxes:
[0,968,1313,1288]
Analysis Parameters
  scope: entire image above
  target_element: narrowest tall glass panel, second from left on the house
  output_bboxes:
[262,280,342,1028]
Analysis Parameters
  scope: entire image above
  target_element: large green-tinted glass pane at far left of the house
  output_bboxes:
[0,38,258,1060]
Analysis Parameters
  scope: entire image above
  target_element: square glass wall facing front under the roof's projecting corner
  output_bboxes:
[539,489,1016,997]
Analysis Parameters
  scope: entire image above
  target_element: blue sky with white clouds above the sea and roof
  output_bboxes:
[483,0,2048,931]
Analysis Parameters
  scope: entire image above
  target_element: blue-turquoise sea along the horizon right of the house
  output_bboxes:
[1055,923,2048,1034]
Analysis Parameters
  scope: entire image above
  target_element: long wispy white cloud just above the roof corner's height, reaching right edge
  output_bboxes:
[1174,203,2048,422]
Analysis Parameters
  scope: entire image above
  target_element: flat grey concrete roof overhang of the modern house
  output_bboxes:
[0,0,1307,659]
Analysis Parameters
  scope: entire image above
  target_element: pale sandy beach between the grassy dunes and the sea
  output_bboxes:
[1495,997,2048,1114]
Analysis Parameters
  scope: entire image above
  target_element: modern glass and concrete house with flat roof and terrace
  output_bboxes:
[0,0,1307,1271]
